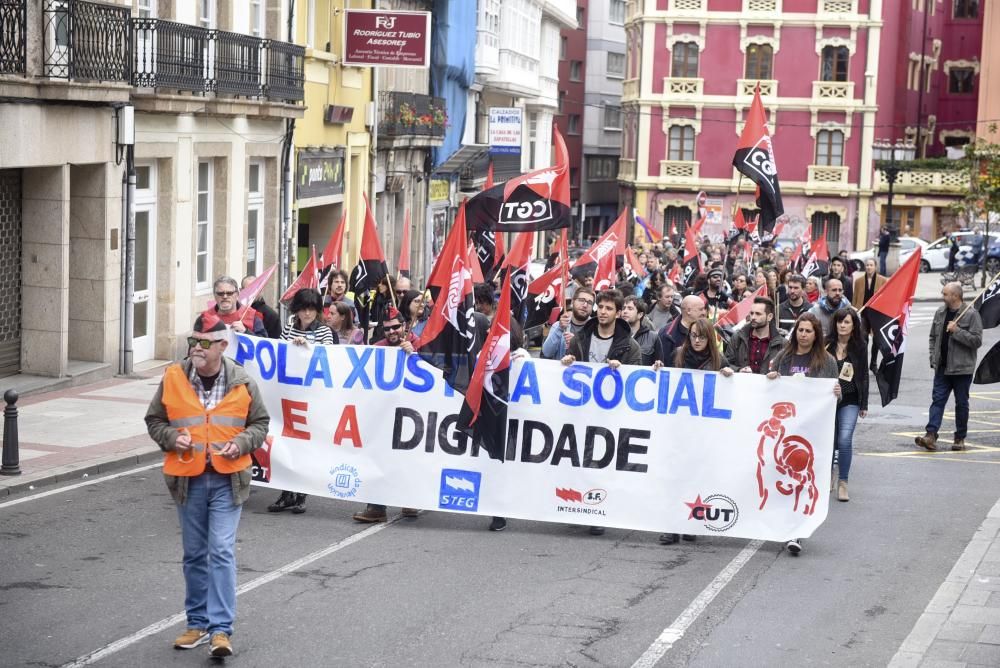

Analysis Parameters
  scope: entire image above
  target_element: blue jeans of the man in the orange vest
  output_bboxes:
[177,473,242,635]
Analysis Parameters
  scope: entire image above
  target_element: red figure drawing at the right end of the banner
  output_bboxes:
[757,401,819,515]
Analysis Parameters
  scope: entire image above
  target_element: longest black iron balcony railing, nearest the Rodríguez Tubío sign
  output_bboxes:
[132,19,305,102]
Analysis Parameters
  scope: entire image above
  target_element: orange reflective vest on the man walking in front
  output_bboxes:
[163,364,251,477]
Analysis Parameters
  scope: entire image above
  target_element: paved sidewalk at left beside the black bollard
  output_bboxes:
[0,369,162,498]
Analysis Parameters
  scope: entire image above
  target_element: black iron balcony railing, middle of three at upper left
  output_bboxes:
[42,0,132,83]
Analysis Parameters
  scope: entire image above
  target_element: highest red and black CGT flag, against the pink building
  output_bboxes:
[733,86,785,234]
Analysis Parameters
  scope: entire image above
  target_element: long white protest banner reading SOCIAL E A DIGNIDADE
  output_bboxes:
[227,335,836,541]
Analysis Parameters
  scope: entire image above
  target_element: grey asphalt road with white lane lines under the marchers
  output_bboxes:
[0,304,1000,667]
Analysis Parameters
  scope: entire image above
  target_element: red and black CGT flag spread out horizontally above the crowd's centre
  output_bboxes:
[466,128,573,232]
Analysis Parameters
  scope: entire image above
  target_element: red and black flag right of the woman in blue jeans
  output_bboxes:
[868,248,920,406]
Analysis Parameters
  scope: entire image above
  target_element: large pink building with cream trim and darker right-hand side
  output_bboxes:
[619,0,982,250]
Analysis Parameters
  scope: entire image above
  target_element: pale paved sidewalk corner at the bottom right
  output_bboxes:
[889,501,1000,668]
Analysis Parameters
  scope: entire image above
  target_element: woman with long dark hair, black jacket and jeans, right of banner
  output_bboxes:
[826,308,868,501]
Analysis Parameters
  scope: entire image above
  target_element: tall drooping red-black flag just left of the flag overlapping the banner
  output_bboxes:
[413,202,477,392]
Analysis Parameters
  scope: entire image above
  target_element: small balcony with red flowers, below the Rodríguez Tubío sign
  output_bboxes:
[378,92,448,148]
